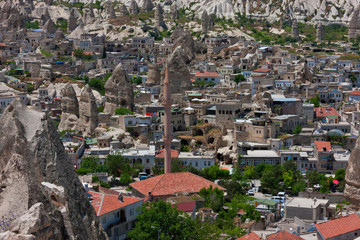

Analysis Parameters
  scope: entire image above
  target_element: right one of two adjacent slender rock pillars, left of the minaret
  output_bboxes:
[78,85,99,136]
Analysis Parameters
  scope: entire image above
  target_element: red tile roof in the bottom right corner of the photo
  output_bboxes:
[315,213,360,239]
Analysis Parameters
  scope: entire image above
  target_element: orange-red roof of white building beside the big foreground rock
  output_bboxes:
[89,191,143,216]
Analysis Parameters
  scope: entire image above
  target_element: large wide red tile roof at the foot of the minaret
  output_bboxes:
[130,172,225,196]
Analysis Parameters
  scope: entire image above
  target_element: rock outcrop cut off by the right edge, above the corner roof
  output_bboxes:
[344,138,360,208]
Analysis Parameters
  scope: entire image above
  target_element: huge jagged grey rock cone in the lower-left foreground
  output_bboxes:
[0,98,108,240]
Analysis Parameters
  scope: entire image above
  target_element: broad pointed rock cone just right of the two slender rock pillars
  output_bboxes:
[104,63,134,114]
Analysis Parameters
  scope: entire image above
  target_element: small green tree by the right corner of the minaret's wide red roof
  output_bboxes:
[199,185,225,212]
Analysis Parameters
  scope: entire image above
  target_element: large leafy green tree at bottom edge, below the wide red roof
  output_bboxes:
[128,201,196,240]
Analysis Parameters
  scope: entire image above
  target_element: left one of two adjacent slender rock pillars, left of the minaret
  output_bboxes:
[59,83,79,131]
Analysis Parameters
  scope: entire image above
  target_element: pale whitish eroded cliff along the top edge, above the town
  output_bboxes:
[59,0,360,24]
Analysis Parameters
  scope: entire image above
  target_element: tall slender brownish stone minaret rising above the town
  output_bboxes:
[163,67,172,173]
